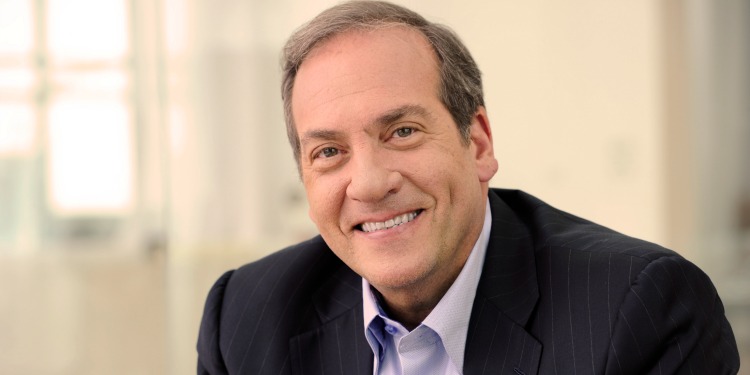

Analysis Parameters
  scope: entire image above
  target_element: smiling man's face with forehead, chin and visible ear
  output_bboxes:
[292,27,497,292]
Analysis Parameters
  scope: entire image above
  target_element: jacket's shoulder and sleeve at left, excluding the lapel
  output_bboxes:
[192,236,345,373]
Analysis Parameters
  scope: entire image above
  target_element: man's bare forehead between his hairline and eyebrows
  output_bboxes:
[292,26,439,130]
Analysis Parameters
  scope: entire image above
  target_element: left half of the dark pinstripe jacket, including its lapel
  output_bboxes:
[198,237,372,374]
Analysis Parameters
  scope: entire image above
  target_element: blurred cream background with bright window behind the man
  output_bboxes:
[0,0,750,374]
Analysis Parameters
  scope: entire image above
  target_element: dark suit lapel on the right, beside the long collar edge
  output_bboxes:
[464,191,542,375]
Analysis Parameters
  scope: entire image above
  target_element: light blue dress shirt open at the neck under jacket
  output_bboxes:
[362,200,492,375]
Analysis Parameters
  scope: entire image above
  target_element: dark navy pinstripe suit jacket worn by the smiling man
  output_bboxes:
[198,189,739,375]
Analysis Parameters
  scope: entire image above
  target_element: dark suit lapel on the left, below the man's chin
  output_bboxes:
[290,265,373,375]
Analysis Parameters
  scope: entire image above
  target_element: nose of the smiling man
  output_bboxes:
[346,150,403,202]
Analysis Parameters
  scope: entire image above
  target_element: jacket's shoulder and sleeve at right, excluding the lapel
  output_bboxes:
[491,189,737,374]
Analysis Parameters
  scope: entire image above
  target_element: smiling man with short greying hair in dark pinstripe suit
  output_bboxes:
[198,2,739,375]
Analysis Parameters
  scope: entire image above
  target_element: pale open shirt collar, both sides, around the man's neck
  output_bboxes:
[362,199,492,369]
